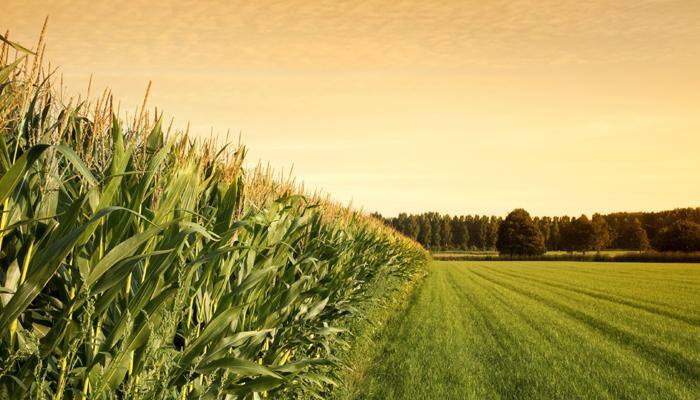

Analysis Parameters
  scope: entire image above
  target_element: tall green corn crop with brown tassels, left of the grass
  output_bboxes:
[0,28,426,399]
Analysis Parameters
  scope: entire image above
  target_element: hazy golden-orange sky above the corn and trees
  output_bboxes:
[0,0,700,216]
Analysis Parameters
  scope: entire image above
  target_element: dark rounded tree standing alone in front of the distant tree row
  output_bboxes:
[496,208,545,256]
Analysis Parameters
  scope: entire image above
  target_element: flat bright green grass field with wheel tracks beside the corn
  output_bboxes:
[355,261,700,399]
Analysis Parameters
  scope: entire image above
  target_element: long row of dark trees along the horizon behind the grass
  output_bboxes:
[374,207,700,254]
